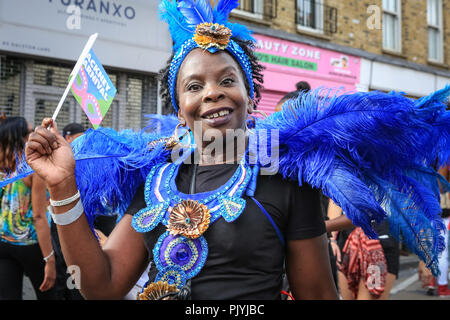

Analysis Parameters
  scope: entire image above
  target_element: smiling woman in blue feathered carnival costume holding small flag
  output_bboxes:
[10,0,450,299]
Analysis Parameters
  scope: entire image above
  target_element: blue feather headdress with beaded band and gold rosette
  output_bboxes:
[158,0,255,111]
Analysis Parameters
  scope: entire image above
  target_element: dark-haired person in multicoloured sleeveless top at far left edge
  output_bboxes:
[0,117,56,300]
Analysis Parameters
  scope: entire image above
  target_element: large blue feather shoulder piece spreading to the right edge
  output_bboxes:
[251,86,450,275]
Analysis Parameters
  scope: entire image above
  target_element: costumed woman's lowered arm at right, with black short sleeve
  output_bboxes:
[285,184,339,300]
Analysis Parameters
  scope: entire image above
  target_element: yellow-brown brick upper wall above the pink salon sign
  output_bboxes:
[248,0,450,70]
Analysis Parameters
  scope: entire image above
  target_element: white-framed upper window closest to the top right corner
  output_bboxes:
[427,0,444,63]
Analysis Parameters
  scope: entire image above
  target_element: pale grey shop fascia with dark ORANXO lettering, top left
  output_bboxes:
[0,0,172,72]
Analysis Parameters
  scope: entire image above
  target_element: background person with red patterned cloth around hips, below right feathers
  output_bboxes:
[326,200,400,300]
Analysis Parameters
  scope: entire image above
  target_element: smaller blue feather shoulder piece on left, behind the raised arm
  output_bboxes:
[0,126,174,234]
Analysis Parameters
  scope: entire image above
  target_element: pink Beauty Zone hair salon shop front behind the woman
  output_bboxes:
[254,34,361,114]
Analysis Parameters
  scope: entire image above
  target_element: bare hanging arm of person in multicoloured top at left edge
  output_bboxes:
[31,174,56,291]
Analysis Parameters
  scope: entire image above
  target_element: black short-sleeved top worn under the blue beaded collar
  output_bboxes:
[127,164,326,300]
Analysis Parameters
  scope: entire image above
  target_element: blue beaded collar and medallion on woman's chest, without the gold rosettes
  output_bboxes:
[133,154,252,288]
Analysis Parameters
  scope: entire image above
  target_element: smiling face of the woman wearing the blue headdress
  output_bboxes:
[177,49,253,155]
